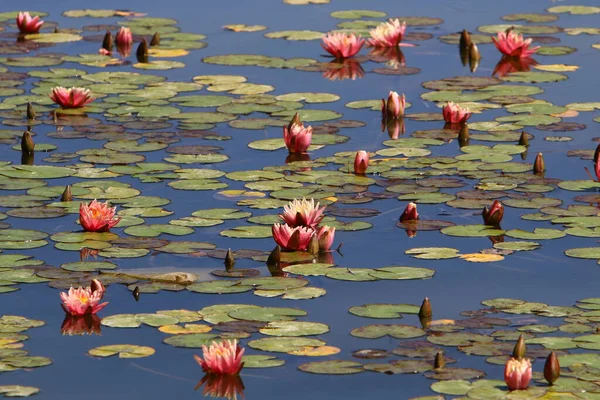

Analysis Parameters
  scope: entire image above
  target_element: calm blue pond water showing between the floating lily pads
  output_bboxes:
[0,0,600,400]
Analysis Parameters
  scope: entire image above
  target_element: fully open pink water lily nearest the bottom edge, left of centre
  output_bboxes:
[194,339,245,375]
